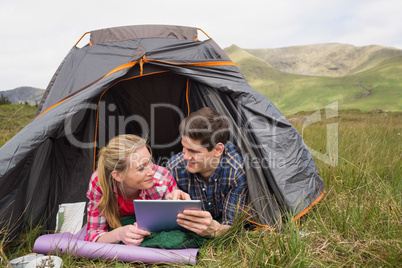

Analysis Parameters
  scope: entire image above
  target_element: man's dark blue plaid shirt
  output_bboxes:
[167,142,248,225]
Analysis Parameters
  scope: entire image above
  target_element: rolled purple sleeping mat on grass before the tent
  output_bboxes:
[34,227,198,264]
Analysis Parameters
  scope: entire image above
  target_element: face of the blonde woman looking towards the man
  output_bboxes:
[116,146,155,197]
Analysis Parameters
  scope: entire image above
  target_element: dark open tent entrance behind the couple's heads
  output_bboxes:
[96,72,200,166]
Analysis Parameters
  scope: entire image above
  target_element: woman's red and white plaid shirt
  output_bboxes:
[85,165,177,241]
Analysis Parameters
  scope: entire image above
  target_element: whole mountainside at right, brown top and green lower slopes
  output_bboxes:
[225,44,402,114]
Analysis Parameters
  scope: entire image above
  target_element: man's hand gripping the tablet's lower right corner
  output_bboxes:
[177,209,230,236]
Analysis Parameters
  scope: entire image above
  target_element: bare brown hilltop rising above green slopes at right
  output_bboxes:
[245,43,402,77]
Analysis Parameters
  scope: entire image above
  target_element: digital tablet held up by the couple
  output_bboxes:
[134,200,201,232]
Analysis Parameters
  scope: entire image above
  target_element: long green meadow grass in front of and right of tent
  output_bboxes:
[0,106,402,267]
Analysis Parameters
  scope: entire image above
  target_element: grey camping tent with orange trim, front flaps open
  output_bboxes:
[0,25,325,241]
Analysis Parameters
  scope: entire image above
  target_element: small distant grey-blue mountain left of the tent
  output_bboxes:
[0,87,45,105]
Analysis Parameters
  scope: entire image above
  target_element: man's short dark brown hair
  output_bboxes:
[179,107,229,151]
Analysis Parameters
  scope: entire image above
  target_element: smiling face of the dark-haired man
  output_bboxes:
[181,135,220,177]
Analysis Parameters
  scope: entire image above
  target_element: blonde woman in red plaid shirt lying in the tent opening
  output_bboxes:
[85,135,183,246]
